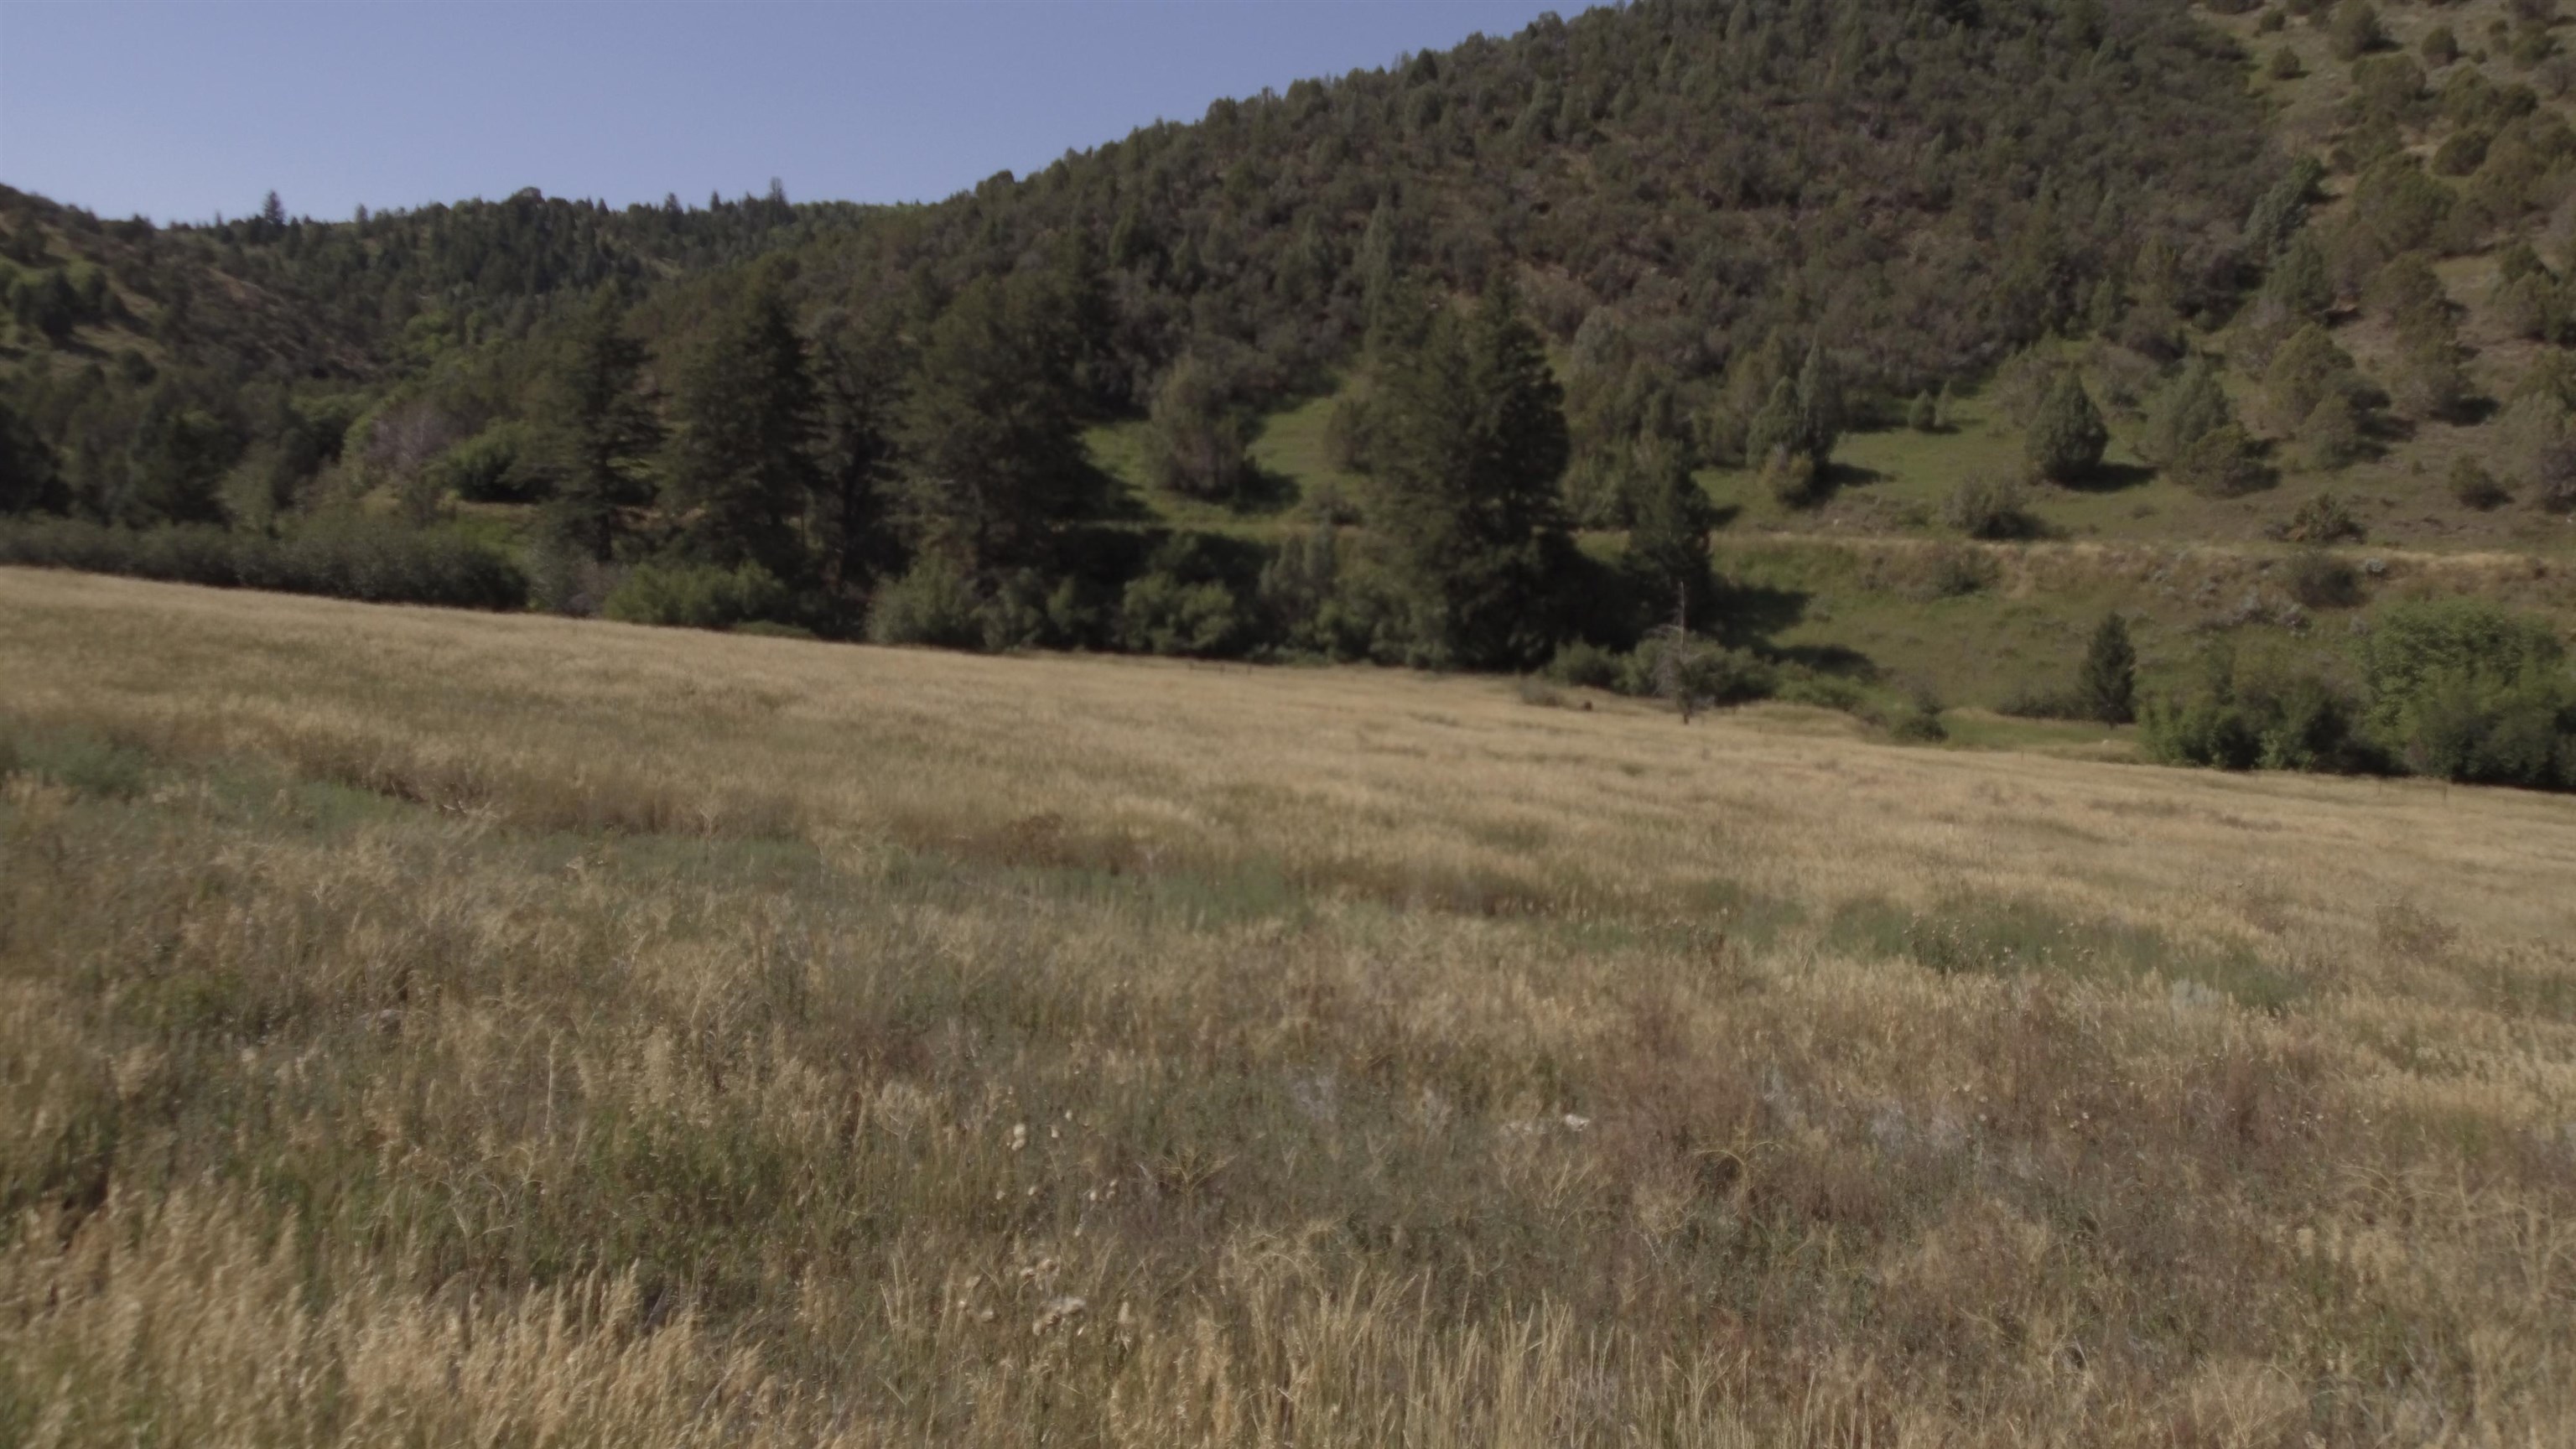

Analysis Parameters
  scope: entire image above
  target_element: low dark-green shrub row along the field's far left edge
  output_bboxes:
[0,518,528,609]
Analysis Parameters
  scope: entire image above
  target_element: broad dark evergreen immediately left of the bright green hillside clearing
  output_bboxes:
[894,278,1098,573]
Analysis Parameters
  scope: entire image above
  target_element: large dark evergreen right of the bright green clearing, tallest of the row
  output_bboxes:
[1370,283,1571,667]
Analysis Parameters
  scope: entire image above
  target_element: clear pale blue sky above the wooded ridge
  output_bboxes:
[0,0,1581,221]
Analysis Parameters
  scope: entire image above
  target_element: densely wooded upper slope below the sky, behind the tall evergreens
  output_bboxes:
[0,0,2272,492]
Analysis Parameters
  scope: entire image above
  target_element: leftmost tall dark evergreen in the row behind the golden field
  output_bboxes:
[536,286,662,562]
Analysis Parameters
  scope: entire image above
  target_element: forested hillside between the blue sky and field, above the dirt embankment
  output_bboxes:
[0,0,2576,783]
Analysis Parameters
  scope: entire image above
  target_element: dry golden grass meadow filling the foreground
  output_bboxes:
[0,570,2576,1446]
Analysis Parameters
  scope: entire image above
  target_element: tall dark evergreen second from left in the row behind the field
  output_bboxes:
[665,268,817,583]
